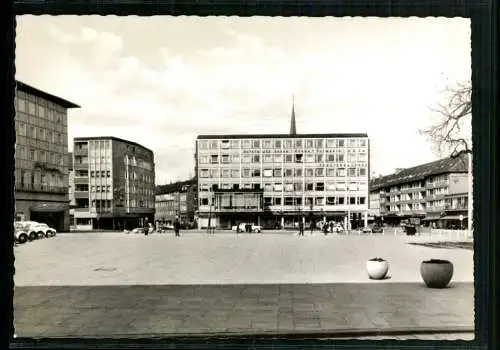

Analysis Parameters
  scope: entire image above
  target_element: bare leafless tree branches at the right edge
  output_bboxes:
[420,81,472,158]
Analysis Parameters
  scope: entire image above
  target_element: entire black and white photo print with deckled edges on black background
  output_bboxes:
[13,15,472,340]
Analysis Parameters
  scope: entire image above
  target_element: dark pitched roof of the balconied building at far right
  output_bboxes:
[370,154,468,191]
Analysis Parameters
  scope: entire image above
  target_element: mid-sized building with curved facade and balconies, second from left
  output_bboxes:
[73,136,155,229]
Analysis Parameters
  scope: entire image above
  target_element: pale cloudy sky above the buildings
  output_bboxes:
[16,16,471,184]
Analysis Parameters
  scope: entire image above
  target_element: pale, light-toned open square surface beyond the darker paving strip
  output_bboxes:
[14,232,474,286]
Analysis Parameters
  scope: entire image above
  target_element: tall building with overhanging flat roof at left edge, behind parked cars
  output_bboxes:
[15,82,79,231]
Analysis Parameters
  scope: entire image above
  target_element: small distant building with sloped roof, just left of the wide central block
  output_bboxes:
[155,179,198,226]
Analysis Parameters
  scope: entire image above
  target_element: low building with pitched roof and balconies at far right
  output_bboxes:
[370,155,468,226]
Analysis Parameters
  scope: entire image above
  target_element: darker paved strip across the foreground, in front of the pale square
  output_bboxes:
[14,283,474,339]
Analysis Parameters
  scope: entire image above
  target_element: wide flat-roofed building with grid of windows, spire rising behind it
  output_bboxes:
[195,134,370,229]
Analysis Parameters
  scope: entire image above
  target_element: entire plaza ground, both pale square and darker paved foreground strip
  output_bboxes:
[14,231,474,339]
